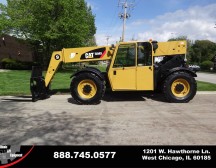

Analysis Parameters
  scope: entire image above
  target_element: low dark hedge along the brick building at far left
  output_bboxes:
[1,58,38,70]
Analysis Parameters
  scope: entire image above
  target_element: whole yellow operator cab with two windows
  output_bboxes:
[108,42,154,91]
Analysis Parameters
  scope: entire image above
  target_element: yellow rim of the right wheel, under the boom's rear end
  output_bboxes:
[171,79,190,98]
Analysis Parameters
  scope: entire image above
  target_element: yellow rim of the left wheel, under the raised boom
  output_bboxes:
[77,79,97,99]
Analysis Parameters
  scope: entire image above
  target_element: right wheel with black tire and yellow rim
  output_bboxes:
[163,71,197,103]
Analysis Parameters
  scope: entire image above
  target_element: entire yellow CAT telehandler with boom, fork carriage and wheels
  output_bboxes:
[30,40,197,104]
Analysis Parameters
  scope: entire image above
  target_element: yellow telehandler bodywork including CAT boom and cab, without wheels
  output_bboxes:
[45,41,187,91]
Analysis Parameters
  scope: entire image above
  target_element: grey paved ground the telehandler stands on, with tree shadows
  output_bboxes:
[0,92,216,145]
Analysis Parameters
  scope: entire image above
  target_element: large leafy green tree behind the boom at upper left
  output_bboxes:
[0,0,96,63]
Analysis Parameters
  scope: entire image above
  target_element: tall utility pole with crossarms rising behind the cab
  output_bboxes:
[118,0,134,41]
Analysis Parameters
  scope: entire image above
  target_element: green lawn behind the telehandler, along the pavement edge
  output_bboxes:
[0,70,216,96]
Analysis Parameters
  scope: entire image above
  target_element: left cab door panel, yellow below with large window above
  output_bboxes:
[108,43,137,91]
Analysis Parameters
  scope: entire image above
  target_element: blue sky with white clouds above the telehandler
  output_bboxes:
[0,0,216,45]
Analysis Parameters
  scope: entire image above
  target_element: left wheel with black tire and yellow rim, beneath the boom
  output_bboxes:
[70,73,106,104]
